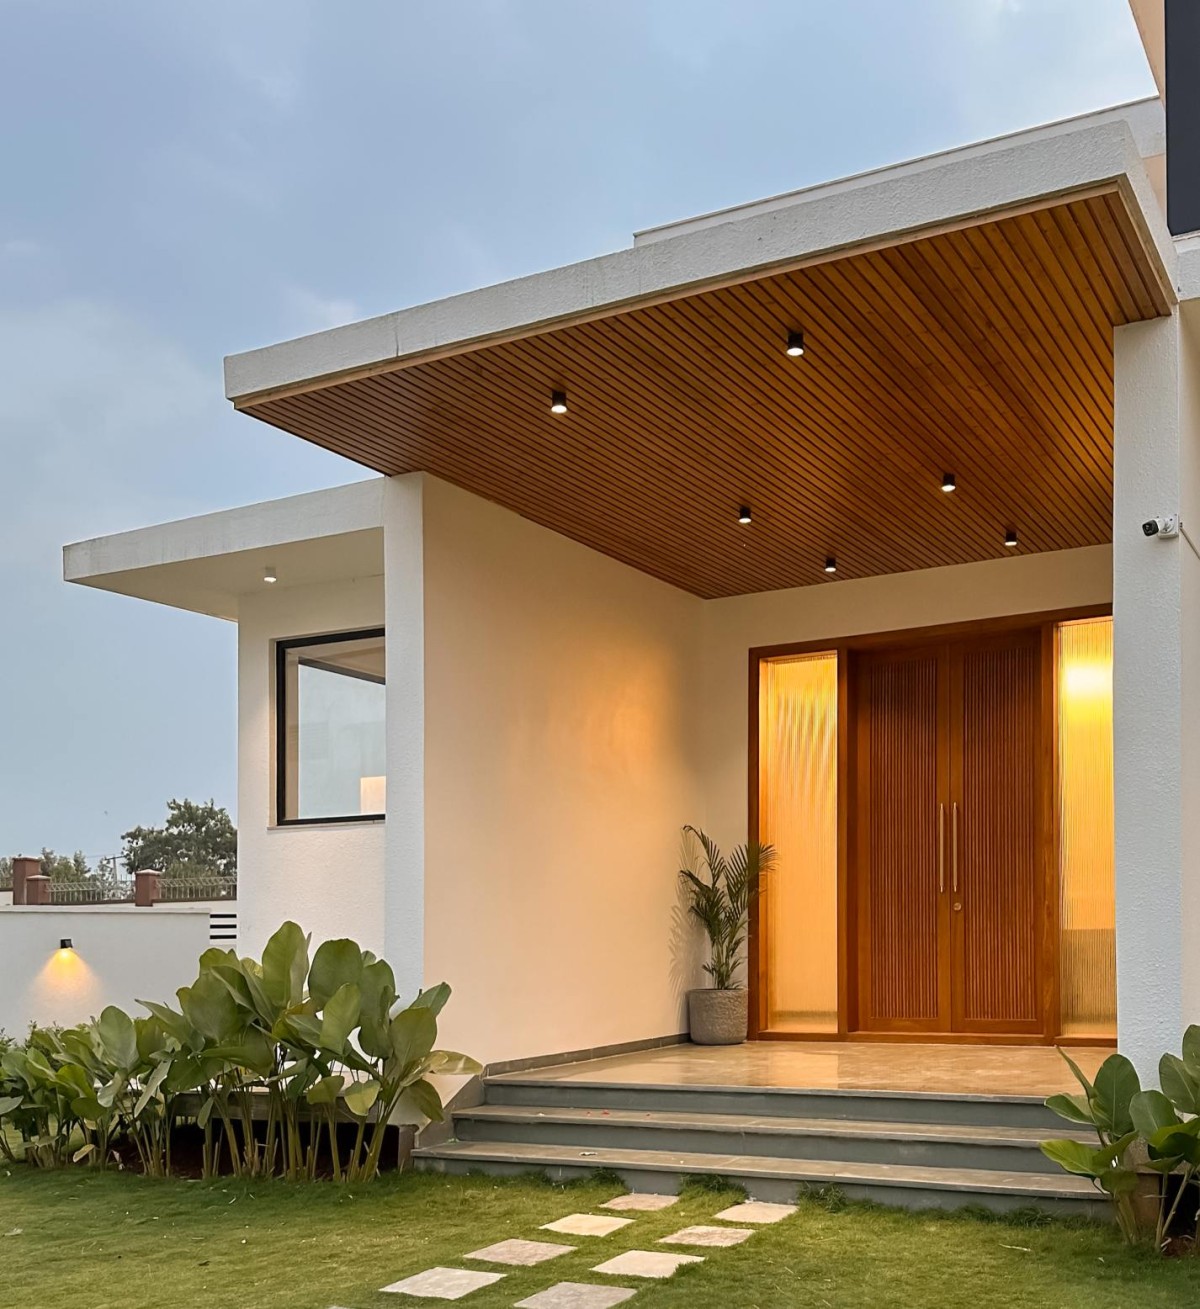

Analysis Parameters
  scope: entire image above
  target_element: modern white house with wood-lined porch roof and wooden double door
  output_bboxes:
[65,4,1200,1089]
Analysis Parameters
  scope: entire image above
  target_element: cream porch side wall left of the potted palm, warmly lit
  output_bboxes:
[418,479,701,1060]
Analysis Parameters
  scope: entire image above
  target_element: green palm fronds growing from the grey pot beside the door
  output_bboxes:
[679,826,775,991]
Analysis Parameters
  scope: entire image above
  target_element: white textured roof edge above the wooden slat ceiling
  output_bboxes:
[225,115,1174,401]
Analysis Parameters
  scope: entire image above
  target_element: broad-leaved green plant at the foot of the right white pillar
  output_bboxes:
[1042,1026,1200,1250]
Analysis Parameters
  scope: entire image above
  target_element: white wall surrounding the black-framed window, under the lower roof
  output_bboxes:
[237,577,385,956]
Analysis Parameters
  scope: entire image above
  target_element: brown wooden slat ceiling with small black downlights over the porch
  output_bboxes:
[242,188,1169,597]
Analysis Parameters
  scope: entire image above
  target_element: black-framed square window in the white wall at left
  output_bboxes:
[279,632,386,819]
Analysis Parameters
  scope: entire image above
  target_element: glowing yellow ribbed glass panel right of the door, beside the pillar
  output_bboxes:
[1057,618,1116,1037]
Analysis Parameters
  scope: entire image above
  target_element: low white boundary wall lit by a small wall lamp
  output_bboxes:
[0,905,208,1035]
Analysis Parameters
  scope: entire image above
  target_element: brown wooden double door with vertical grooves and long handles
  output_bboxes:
[851,631,1050,1039]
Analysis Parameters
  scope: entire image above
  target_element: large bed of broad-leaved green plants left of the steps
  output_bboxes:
[0,923,479,1181]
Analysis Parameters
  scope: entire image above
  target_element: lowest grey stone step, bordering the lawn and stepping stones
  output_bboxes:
[414,1141,1108,1219]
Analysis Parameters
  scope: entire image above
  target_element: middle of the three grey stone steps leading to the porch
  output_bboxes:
[454,1105,1085,1177]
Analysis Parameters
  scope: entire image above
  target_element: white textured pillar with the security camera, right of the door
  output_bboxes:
[1112,317,1182,1085]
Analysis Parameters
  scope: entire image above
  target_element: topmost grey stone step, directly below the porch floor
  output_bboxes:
[487,1072,1068,1136]
